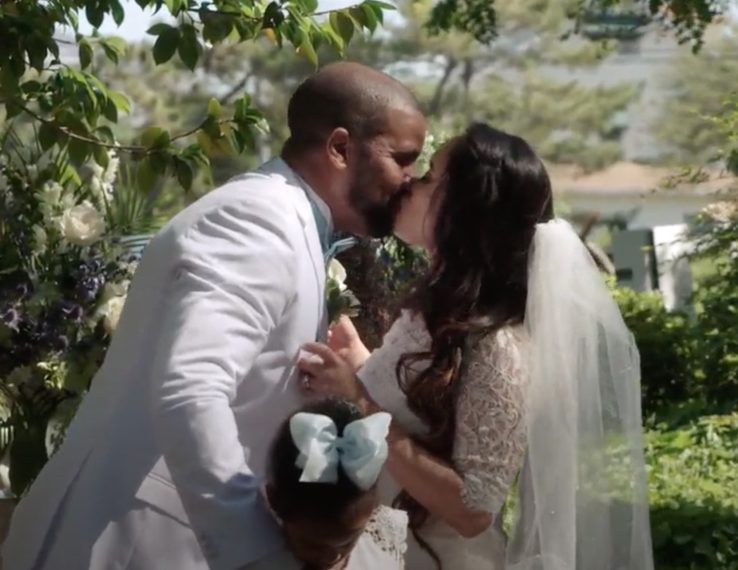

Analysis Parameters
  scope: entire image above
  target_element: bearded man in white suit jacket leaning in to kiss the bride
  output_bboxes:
[3,63,425,570]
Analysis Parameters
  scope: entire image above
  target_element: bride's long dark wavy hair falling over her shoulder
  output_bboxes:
[396,123,553,568]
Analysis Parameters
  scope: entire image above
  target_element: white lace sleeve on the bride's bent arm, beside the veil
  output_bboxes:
[454,329,527,513]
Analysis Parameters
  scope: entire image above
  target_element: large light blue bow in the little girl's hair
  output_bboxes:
[290,412,392,491]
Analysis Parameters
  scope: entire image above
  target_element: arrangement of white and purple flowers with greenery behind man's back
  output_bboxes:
[0,129,135,496]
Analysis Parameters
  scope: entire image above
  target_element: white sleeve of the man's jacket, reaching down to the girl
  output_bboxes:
[151,193,296,570]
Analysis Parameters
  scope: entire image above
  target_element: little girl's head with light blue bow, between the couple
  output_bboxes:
[267,399,389,568]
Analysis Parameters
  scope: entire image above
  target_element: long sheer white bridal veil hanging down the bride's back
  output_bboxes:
[506,220,653,570]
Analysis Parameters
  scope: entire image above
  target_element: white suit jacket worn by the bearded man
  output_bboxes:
[3,159,325,570]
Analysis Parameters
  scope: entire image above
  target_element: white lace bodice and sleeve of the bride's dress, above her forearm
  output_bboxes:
[359,312,528,513]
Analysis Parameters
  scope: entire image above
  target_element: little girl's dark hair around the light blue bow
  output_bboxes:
[269,398,374,522]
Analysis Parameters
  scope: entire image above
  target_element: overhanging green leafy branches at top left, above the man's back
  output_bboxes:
[0,0,390,196]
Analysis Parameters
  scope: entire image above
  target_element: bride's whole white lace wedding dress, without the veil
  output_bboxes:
[359,311,528,570]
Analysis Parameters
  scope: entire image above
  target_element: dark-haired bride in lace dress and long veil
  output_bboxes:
[300,124,653,570]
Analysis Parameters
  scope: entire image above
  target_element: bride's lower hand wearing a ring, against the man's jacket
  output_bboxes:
[297,342,364,401]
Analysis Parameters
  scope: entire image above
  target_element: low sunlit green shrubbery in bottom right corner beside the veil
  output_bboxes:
[647,413,738,570]
